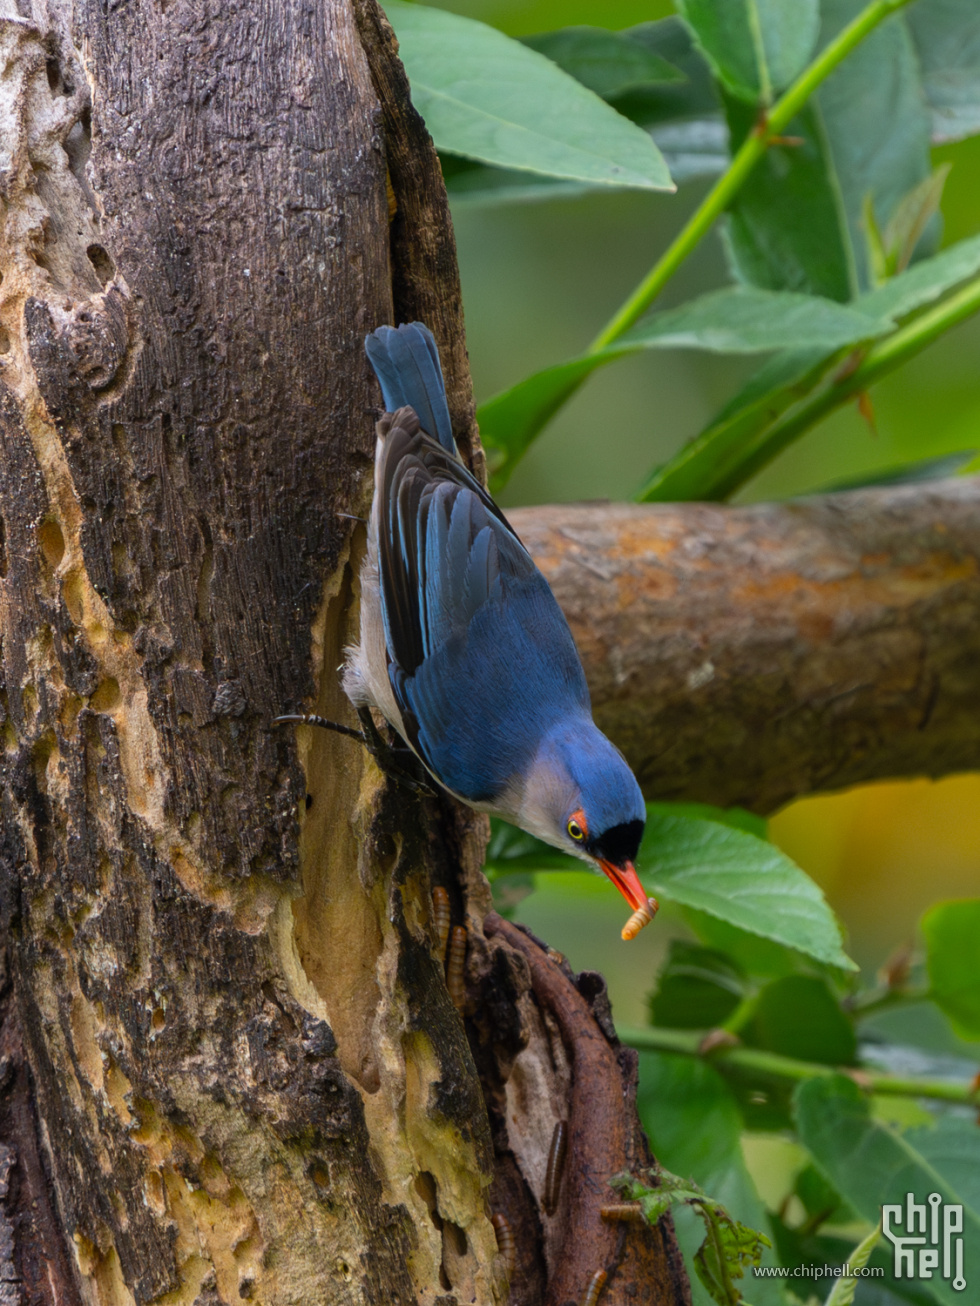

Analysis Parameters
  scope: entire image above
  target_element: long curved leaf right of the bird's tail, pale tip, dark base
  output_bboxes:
[477,286,891,490]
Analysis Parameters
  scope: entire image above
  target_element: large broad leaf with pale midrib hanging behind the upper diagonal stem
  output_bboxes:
[727,0,938,300]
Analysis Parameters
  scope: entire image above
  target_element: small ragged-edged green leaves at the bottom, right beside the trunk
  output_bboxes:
[609,1169,772,1306]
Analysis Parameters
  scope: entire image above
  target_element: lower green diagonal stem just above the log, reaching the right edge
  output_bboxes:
[707,267,980,499]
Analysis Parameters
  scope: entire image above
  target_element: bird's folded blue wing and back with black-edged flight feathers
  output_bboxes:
[378,410,588,802]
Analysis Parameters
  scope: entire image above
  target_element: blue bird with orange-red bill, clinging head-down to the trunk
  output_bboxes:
[287,323,651,929]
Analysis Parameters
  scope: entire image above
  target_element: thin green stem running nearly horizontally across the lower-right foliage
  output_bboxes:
[617,1028,977,1106]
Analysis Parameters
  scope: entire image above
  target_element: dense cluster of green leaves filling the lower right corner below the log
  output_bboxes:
[621,901,980,1306]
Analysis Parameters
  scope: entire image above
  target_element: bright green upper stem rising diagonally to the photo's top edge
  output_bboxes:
[588,0,909,354]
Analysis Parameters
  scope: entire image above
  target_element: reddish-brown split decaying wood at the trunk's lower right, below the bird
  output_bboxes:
[485,913,690,1306]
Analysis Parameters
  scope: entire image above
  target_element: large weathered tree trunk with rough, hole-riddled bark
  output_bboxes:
[0,0,689,1306]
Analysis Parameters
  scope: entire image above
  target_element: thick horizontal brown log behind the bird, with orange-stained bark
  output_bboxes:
[510,477,980,812]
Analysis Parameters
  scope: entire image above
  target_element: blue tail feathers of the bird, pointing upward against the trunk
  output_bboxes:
[365,323,456,454]
